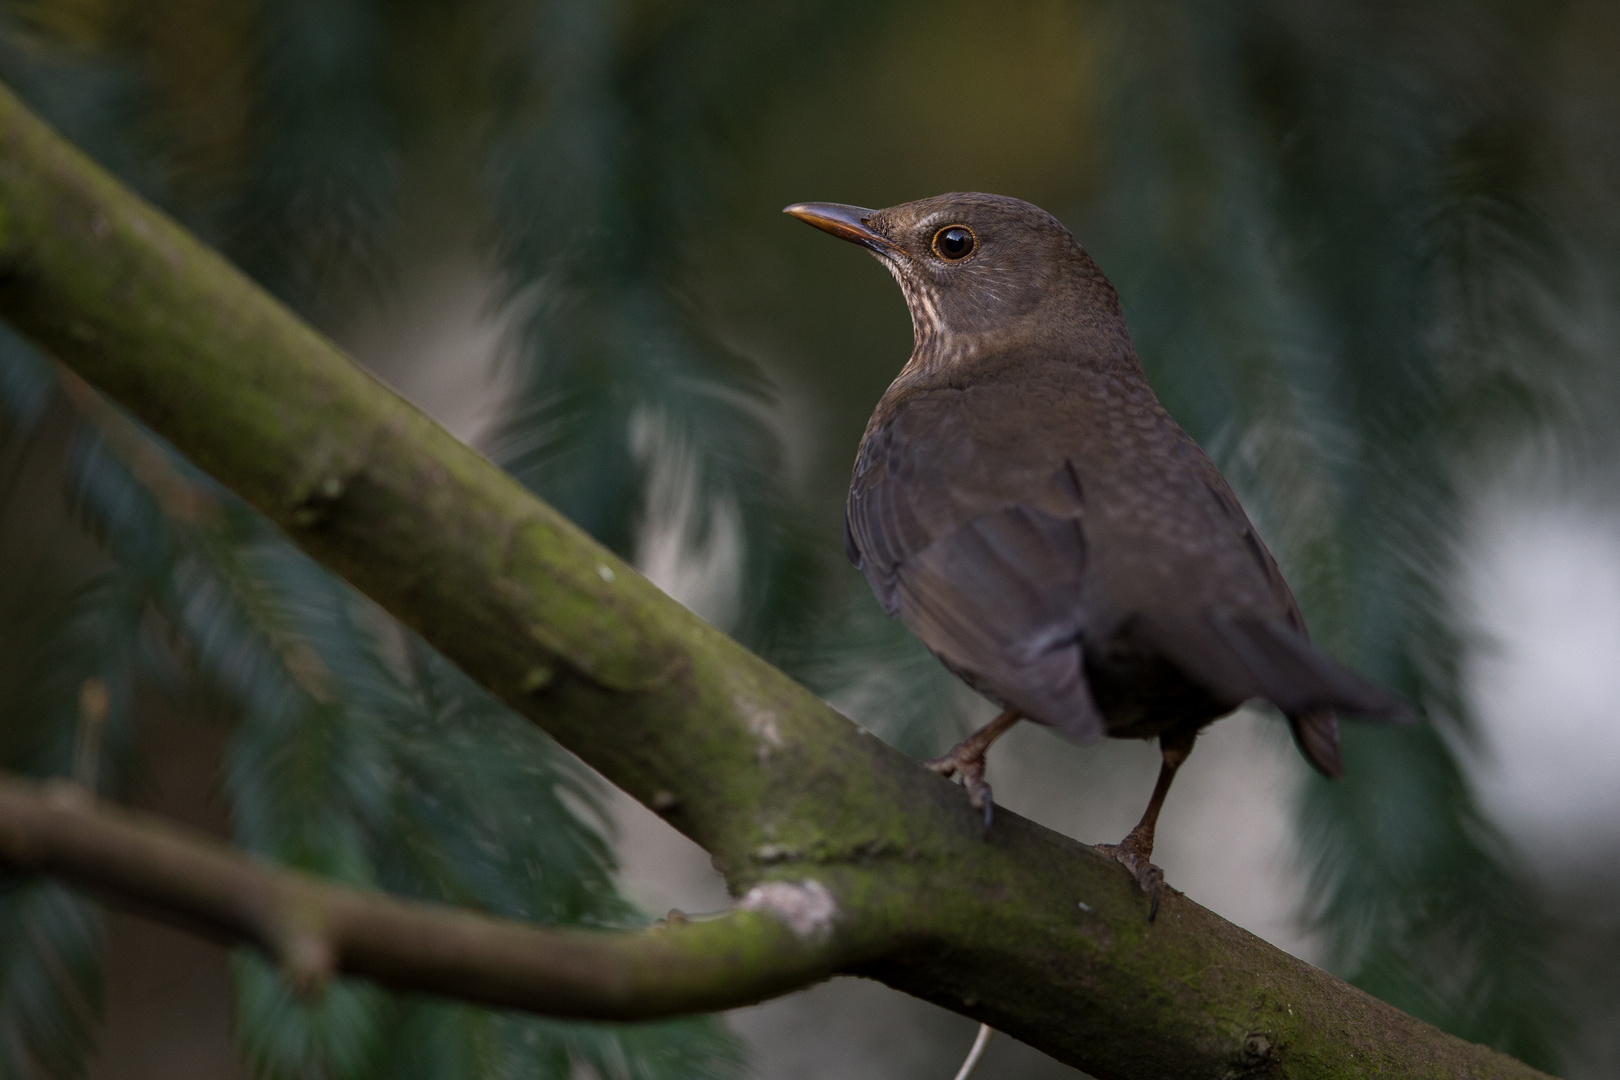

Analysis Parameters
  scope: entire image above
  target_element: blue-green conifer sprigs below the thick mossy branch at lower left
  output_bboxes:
[0,296,740,1080]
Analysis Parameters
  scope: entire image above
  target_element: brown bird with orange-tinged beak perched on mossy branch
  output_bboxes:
[786,194,1406,918]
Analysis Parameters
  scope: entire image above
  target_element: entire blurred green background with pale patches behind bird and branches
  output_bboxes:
[0,0,1620,1080]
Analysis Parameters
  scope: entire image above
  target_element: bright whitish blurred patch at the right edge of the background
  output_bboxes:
[1463,492,1620,878]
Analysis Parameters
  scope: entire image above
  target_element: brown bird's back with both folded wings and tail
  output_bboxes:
[846,387,1406,761]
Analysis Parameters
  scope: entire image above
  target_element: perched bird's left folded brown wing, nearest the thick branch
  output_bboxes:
[846,400,1103,742]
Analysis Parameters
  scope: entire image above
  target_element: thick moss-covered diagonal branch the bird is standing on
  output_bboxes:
[0,80,1541,1080]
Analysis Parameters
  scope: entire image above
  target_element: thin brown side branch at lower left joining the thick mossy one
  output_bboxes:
[0,779,852,1020]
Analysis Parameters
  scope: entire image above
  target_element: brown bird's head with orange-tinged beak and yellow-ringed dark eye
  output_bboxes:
[782,193,1129,363]
